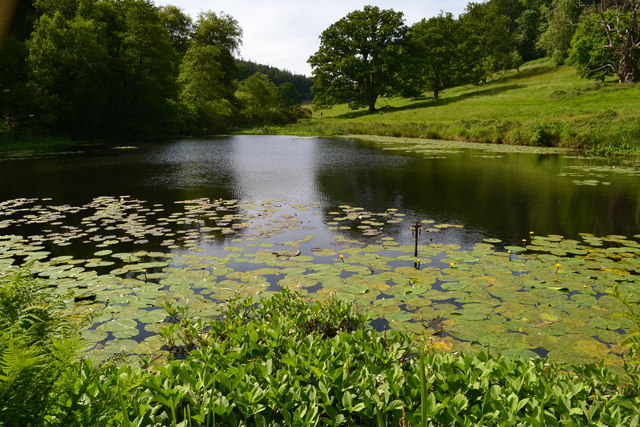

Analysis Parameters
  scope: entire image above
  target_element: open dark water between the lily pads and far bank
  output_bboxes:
[0,136,640,246]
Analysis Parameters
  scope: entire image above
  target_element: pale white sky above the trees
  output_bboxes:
[154,0,470,75]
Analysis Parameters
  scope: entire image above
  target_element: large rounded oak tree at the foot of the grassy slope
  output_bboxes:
[308,6,408,112]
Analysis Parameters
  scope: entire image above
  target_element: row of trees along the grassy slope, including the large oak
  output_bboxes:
[308,0,640,112]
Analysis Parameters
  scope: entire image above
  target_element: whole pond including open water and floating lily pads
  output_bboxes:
[0,136,640,365]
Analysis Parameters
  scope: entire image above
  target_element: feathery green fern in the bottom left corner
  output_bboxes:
[0,270,84,425]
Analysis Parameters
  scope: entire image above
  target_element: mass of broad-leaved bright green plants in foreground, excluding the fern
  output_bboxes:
[119,290,640,425]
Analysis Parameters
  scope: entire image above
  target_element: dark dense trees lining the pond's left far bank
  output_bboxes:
[0,0,306,139]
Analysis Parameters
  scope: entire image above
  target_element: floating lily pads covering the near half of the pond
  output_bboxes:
[0,197,640,364]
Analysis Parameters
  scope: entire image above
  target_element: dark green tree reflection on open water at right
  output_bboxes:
[318,142,639,239]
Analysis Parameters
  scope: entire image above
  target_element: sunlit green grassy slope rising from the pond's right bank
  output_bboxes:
[254,60,640,154]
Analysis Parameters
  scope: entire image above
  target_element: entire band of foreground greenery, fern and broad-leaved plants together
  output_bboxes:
[0,273,640,426]
